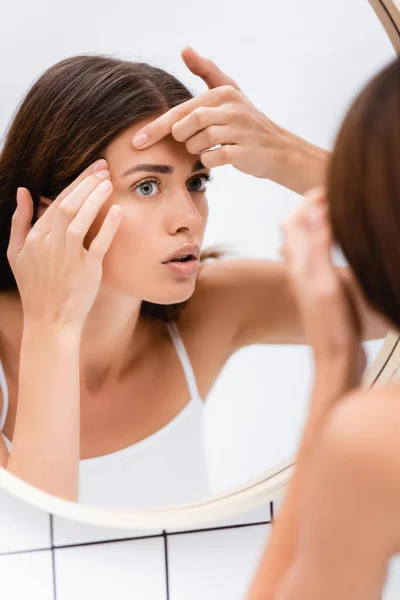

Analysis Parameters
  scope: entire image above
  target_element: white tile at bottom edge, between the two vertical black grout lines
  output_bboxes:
[54,538,167,600]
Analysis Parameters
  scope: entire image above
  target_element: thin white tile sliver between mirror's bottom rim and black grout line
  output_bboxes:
[53,516,162,546]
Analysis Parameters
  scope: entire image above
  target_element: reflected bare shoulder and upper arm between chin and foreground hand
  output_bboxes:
[182,258,303,352]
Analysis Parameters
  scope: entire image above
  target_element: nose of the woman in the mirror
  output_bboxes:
[167,189,207,234]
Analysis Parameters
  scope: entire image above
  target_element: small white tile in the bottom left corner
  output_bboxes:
[0,550,54,600]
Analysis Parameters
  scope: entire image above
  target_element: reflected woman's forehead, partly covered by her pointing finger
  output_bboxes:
[105,117,200,175]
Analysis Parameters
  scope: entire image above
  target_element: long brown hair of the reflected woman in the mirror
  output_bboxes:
[0,55,231,321]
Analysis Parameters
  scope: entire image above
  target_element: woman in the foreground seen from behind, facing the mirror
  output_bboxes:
[247,58,400,600]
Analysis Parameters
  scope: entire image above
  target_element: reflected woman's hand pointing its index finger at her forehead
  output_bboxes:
[133,48,292,181]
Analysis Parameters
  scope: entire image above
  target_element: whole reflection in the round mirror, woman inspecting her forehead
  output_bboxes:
[0,0,394,508]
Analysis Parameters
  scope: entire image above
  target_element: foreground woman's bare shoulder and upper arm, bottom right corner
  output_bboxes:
[274,386,400,600]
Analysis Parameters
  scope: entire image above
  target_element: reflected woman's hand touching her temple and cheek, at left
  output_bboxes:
[7,159,120,331]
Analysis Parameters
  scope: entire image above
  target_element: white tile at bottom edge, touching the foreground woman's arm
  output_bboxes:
[168,525,270,600]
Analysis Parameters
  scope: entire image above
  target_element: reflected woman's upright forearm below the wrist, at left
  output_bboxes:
[6,323,80,502]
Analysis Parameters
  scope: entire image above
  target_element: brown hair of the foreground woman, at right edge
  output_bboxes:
[327,58,400,329]
